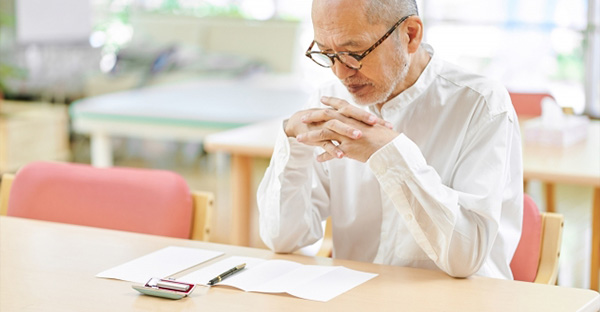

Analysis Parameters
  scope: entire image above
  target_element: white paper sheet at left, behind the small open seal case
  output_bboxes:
[96,246,223,284]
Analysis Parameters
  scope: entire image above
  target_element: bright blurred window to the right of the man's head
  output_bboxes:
[421,0,598,114]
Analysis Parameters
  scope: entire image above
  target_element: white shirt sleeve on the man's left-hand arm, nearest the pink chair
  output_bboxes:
[257,116,329,253]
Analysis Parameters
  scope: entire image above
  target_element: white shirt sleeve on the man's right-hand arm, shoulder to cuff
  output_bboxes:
[367,106,522,277]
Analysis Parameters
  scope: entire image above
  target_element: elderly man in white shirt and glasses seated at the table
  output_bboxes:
[258,0,523,279]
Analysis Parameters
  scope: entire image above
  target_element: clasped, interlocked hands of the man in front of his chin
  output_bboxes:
[284,97,398,162]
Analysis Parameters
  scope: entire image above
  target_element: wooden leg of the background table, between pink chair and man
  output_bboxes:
[231,155,253,246]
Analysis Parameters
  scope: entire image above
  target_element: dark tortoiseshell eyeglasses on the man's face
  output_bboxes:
[304,15,411,70]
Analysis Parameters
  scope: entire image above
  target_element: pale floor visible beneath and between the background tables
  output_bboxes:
[73,138,592,288]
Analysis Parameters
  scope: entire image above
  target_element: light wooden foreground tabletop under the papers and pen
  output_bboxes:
[0,217,600,312]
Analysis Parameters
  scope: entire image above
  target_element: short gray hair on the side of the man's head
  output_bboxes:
[365,0,419,25]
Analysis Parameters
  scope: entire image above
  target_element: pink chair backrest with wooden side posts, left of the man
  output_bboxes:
[0,162,213,239]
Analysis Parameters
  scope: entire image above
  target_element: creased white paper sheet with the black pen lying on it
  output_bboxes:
[178,256,377,302]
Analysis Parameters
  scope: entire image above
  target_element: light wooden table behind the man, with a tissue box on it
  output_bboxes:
[205,119,600,290]
